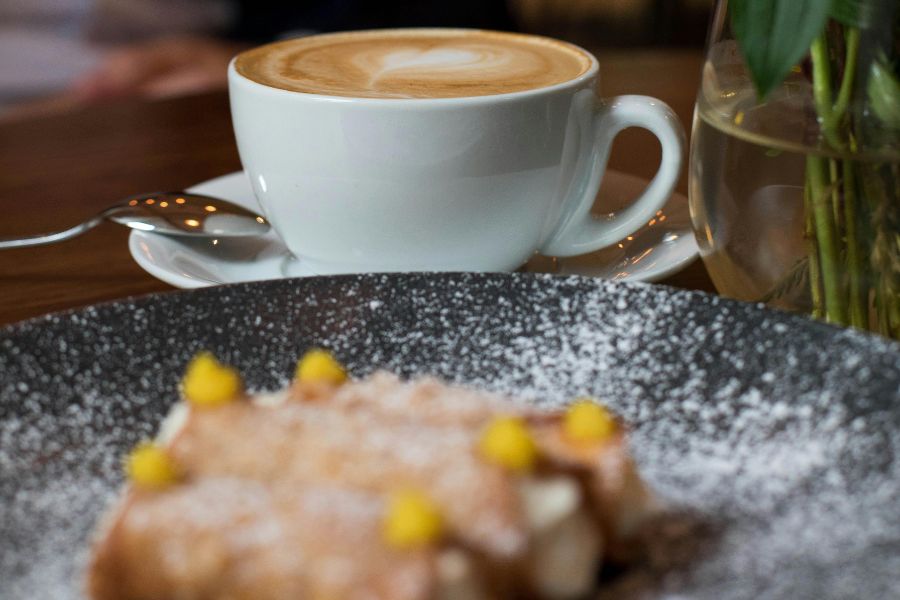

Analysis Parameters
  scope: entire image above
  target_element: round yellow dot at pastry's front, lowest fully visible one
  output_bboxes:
[383,491,444,549]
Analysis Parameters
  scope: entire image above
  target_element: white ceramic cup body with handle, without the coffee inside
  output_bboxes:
[228,31,684,274]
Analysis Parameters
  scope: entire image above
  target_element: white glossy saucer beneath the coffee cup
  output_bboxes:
[128,171,698,288]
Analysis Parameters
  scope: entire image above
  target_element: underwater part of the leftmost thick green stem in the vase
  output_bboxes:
[806,155,847,324]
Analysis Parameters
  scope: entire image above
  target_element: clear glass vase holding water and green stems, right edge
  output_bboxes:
[689,0,900,339]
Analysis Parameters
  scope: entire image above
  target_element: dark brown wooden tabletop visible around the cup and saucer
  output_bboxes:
[0,50,713,325]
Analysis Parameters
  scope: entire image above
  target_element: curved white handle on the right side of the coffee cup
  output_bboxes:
[540,90,685,256]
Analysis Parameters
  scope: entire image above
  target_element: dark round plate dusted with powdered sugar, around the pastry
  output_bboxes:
[0,274,900,599]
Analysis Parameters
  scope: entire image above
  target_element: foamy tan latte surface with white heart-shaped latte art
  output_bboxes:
[235,29,591,98]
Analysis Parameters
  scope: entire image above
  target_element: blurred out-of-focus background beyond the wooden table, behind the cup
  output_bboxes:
[0,0,712,121]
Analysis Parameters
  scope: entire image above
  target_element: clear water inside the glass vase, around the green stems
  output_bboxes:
[690,86,900,318]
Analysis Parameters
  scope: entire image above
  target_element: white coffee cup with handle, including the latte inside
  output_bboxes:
[228,29,684,274]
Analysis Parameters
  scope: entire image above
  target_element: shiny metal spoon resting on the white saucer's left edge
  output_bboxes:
[0,192,269,250]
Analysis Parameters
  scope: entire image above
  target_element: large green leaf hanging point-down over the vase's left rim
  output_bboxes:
[729,0,832,98]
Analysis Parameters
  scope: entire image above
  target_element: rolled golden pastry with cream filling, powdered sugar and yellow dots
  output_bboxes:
[87,352,648,600]
